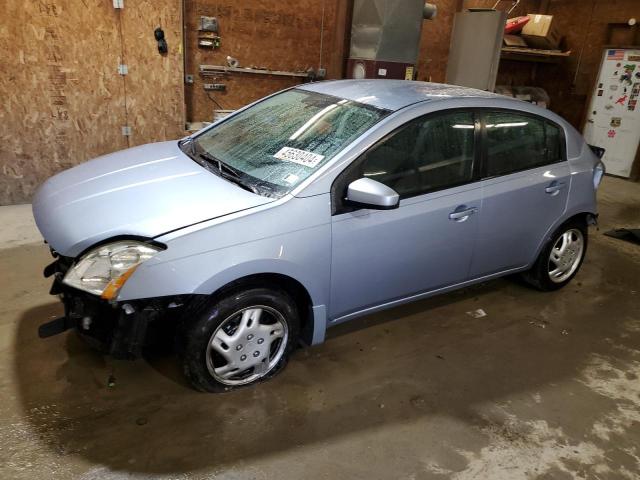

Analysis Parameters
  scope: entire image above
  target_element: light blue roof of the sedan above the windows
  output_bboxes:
[297,80,508,110]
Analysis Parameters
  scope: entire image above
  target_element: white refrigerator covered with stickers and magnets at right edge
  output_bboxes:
[583,48,640,177]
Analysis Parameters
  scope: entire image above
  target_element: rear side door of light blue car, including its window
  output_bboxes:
[471,110,571,277]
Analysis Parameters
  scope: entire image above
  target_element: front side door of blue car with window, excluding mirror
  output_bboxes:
[330,111,481,320]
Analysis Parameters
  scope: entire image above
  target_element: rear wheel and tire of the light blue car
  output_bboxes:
[522,218,589,292]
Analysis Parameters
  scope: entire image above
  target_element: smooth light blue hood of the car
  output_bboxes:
[33,141,272,257]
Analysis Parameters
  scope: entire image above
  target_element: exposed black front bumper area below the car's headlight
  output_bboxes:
[38,251,190,359]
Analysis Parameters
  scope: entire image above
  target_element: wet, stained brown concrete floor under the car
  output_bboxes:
[0,178,640,480]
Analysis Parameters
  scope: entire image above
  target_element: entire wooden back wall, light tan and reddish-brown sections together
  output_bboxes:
[5,0,640,205]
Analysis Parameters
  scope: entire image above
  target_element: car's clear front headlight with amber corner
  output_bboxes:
[62,240,162,300]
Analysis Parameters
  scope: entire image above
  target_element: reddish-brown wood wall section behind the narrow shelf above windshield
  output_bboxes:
[185,0,340,121]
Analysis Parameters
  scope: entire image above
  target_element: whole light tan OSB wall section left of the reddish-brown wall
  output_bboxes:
[0,0,183,205]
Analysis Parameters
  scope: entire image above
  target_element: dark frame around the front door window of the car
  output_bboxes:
[330,107,482,216]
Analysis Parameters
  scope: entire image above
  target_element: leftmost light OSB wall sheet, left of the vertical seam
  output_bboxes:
[0,0,126,205]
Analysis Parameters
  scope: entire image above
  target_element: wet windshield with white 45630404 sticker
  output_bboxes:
[186,89,389,197]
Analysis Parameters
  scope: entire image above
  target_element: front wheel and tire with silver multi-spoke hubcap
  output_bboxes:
[177,288,300,393]
